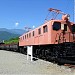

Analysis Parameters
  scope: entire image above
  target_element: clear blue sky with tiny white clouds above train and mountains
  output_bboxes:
[0,0,74,29]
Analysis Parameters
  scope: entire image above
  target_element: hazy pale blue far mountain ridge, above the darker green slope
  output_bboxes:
[0,28,26,35]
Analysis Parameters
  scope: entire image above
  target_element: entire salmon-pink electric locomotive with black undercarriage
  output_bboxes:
[19,8,75,64]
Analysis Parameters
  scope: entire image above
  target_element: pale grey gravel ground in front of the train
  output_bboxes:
[0,50,75,75]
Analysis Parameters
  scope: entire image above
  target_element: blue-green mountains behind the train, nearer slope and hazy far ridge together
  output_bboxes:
[0,28,26,41]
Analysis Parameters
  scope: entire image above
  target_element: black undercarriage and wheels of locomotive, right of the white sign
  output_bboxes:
[33,42,75,64]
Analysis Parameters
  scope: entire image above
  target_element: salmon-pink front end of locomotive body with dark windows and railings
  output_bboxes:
[51,20,75,44]
